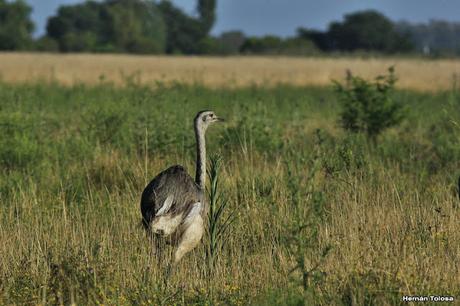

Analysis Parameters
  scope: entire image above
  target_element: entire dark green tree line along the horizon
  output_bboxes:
[0,0,460,55]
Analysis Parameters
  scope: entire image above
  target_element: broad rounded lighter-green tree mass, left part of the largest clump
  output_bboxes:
[47,0,165,53]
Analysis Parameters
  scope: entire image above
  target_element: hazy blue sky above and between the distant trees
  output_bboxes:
[26,0,460,36]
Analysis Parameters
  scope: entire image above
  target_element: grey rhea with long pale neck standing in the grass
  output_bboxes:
[141,110,223,264]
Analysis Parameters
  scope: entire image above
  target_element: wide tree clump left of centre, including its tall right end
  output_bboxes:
[44,0,215,54]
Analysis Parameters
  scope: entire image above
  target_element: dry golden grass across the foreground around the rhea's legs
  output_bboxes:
[0,148,460,305]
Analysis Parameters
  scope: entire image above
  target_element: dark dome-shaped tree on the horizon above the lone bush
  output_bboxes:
[327,10,413,52]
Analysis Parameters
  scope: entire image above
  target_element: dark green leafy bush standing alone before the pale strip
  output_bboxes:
[334,67,404,142]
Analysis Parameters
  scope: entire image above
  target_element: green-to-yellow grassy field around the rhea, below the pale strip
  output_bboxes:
[0,66,460,305]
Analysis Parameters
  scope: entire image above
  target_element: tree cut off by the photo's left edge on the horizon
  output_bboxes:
[0,0,34,50]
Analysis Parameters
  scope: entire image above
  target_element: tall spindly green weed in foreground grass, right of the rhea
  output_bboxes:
[285,130,332,302]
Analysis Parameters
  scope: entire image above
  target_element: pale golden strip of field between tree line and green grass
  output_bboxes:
[0,53,460,91]
